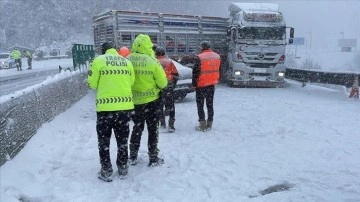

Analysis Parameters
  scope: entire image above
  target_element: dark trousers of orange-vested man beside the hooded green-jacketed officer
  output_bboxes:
[160,87,175,122]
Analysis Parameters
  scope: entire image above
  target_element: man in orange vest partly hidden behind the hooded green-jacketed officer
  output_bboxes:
[155,46,179,133]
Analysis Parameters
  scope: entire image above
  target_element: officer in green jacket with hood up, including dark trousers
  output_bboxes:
[127,34,167,166]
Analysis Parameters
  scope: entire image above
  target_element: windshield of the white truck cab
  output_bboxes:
[239,27,286,40]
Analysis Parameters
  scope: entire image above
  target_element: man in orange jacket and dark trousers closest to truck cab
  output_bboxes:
[192,41,221,132]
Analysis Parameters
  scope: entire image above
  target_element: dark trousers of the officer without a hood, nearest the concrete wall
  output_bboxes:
[96,110,132,170]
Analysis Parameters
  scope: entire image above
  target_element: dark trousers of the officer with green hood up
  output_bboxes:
[130,99,160,160]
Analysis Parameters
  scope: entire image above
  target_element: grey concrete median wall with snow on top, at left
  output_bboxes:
[0,71,89,165]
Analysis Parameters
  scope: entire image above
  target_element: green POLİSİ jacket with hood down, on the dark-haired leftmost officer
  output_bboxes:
[88,48,135,112]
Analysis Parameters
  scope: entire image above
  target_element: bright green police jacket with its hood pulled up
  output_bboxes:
[127,34,167,105]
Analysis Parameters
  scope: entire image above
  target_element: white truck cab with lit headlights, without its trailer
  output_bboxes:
[226,3,293,87]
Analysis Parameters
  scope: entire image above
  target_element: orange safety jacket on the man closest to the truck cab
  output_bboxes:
[197,49,220,87]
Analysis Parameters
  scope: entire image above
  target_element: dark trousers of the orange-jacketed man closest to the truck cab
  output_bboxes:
[196,85,215,121]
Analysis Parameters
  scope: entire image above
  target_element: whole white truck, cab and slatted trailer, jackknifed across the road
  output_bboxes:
[93,3,294,87]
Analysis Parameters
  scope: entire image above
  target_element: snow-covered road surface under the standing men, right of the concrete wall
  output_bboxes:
[0,81,360,202]
